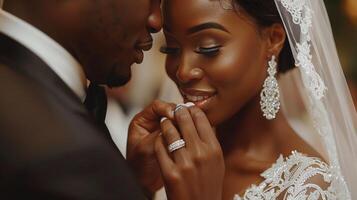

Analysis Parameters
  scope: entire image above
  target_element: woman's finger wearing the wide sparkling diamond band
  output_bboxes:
[161,119,187,162]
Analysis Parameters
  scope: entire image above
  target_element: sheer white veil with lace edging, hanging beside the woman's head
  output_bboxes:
[275,0,357,199]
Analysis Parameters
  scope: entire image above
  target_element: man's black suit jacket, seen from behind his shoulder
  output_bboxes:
[0,34,144,200]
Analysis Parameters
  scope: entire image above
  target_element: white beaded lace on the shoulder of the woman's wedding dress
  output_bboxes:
[234,151,343,200]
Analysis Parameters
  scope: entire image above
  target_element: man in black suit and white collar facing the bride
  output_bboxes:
[0,0,171,200]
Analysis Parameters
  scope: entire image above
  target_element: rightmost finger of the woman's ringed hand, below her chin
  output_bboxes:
[189,106,219,146]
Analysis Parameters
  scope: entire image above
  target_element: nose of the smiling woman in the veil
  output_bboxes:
[176,59,204,83]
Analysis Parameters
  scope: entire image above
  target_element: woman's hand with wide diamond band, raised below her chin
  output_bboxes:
[155,106,225,200]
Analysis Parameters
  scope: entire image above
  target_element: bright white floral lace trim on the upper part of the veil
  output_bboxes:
[280,0,327,100]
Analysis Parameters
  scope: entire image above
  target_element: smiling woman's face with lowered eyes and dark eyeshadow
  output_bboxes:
[161,0,271,125]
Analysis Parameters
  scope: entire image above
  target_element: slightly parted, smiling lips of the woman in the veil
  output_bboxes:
[180,88,217,110]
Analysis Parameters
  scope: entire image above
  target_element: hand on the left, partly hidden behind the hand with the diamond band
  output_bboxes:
[127,100,175,194]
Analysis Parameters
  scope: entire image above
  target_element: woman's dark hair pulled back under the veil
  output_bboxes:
[220,0,295,73]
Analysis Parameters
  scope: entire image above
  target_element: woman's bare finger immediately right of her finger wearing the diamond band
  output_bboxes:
[175,107,200,149]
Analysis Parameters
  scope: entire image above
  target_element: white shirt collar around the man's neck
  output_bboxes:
[0,9,87,101]
